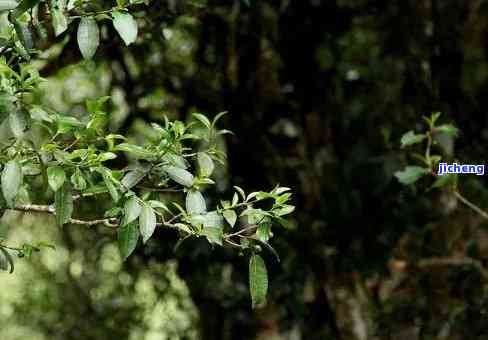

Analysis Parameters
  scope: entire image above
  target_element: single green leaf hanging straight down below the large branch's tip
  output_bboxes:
[249,255,268,308]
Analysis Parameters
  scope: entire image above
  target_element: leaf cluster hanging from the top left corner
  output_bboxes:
[0,0,150,60]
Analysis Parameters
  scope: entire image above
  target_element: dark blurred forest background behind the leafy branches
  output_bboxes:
[0,0,488,340]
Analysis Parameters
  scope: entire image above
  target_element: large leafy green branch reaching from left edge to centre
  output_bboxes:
[0,54,293,306]
